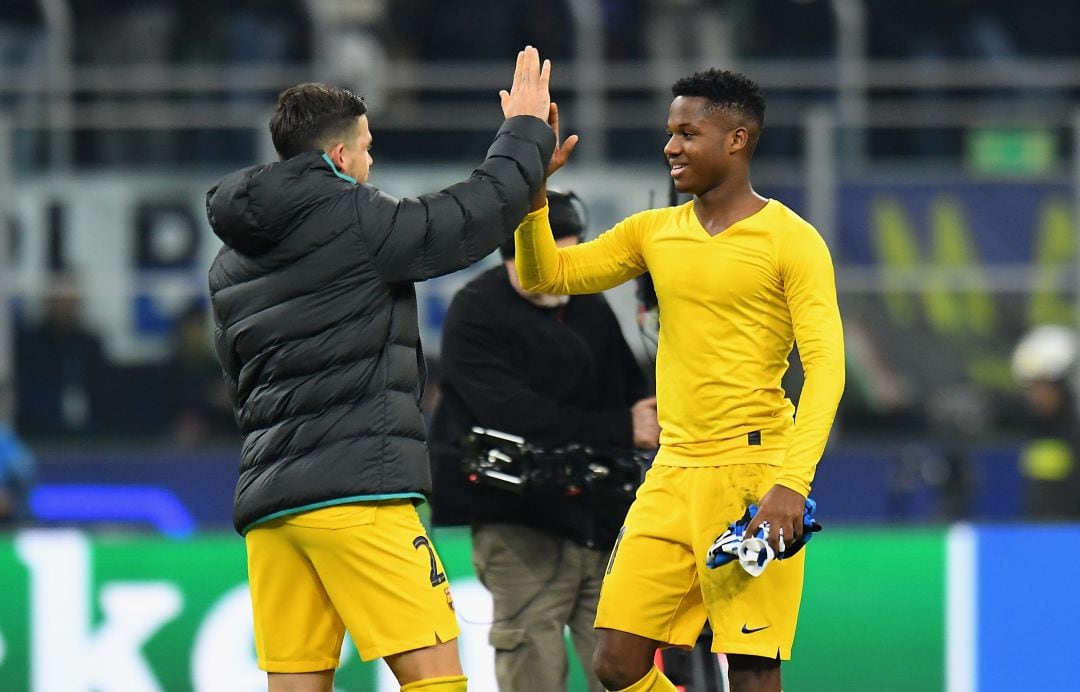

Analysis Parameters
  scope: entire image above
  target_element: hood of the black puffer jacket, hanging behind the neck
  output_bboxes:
[206,151,351,255]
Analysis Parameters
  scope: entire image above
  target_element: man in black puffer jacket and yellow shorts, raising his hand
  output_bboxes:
[206,48,576,692]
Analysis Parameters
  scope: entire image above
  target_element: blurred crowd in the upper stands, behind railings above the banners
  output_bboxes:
[0,0,1080,166]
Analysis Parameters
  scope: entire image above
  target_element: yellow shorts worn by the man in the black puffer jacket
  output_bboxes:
[246,500,459,673]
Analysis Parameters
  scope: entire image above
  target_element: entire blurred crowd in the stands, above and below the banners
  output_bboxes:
[0,0,1080,521]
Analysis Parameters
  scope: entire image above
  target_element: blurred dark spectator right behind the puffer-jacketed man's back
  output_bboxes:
[163,300,238,447]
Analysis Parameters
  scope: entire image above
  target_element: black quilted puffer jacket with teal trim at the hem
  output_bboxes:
[206,116,554,533]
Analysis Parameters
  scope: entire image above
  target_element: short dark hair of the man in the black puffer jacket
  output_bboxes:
[270,83,367,161]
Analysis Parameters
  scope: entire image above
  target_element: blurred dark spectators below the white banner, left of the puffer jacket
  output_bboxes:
[15,275,239,448]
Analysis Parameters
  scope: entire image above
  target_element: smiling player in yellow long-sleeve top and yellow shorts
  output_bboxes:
[516,70,843,692]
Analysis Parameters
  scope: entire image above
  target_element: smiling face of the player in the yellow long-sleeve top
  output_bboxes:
[664,96,751,196]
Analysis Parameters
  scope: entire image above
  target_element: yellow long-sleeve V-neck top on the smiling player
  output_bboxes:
[516,200,845,496]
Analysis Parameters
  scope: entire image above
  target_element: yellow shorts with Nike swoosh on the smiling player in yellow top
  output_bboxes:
[596,463,806,660]
